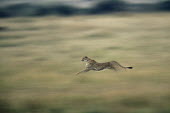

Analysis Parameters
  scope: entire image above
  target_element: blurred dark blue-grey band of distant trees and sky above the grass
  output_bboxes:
[0,0,170,17]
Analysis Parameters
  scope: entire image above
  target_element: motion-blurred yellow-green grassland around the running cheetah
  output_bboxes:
[0,13,170,113]
